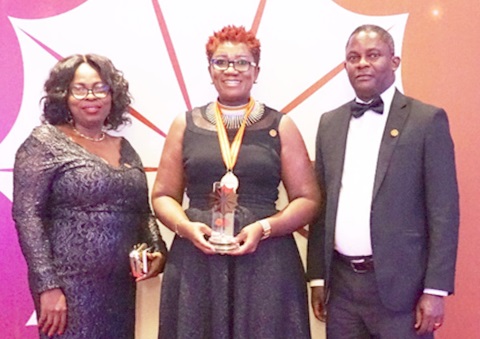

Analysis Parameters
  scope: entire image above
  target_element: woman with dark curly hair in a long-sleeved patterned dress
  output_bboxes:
[13,54,166,339]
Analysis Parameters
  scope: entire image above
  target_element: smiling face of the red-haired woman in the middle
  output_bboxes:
[209,42,260,106]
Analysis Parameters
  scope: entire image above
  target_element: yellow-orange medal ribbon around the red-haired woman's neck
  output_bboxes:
[215,98,255,172]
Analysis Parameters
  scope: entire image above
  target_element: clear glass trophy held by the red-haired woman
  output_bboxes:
[208,172,238,253]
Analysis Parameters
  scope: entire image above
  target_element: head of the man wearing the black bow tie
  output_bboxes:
[344,31,400,101]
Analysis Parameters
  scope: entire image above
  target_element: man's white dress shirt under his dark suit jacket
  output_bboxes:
[335,86,395,256]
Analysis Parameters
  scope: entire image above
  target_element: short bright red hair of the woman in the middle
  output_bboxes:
[205,25,260,65]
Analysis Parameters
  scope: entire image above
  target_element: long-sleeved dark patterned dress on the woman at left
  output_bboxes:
[13,125,165,339]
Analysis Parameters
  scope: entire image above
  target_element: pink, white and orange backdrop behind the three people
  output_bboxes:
[0,0,480,339]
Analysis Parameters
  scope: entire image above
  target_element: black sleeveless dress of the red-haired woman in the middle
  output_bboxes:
[159,106,310,339]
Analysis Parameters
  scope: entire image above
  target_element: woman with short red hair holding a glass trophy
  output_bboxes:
[152,26,320,339]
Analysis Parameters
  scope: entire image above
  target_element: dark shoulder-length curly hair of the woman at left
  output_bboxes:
[41,54,132,130]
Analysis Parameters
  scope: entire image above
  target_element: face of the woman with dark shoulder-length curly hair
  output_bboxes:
[68,63,112,131]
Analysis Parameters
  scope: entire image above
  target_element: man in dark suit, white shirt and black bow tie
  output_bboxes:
[307,25,459,339]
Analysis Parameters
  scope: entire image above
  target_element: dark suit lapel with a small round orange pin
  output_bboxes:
[373,90,410,199]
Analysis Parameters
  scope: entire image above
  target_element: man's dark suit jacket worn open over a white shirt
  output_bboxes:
[307,91,459,311]
